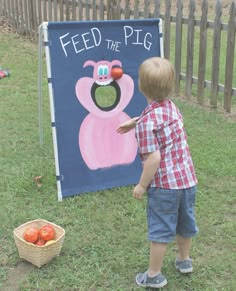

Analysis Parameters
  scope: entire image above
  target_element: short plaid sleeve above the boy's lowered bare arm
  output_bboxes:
[135,120,160,154]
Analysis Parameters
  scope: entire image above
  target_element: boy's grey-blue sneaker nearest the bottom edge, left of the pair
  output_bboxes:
[135,271,167,288]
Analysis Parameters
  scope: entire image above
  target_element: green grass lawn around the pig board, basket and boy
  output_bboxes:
[0,32,236,291]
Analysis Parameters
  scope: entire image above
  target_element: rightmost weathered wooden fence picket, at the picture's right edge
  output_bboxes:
[224,1,236,112]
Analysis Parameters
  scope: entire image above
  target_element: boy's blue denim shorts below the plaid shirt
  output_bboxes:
[147,186,198,243]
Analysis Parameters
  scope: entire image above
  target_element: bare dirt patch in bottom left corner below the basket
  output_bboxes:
[1,262,35,291]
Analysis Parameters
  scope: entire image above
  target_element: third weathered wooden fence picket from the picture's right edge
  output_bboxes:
[197,0,208,104]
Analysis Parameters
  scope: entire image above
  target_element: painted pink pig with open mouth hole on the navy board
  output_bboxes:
[75,60,137,170]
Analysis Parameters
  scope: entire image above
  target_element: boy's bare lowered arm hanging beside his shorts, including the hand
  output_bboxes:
[133,151,161,199]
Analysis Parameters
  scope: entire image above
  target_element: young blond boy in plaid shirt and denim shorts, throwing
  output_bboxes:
[117,57,198,288]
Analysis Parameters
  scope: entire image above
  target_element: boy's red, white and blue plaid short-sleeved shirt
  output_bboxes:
[136,99,197,189]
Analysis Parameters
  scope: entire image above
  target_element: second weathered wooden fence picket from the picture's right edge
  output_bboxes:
[210,0,222,107]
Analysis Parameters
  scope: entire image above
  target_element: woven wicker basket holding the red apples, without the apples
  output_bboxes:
[13,219,65,268]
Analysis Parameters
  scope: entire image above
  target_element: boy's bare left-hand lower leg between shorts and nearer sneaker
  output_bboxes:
[148,242,167,277]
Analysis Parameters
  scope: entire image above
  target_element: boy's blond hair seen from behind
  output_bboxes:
[139,57,175,101]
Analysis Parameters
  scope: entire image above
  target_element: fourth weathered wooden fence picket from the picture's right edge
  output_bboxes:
[185,0,195,98]
